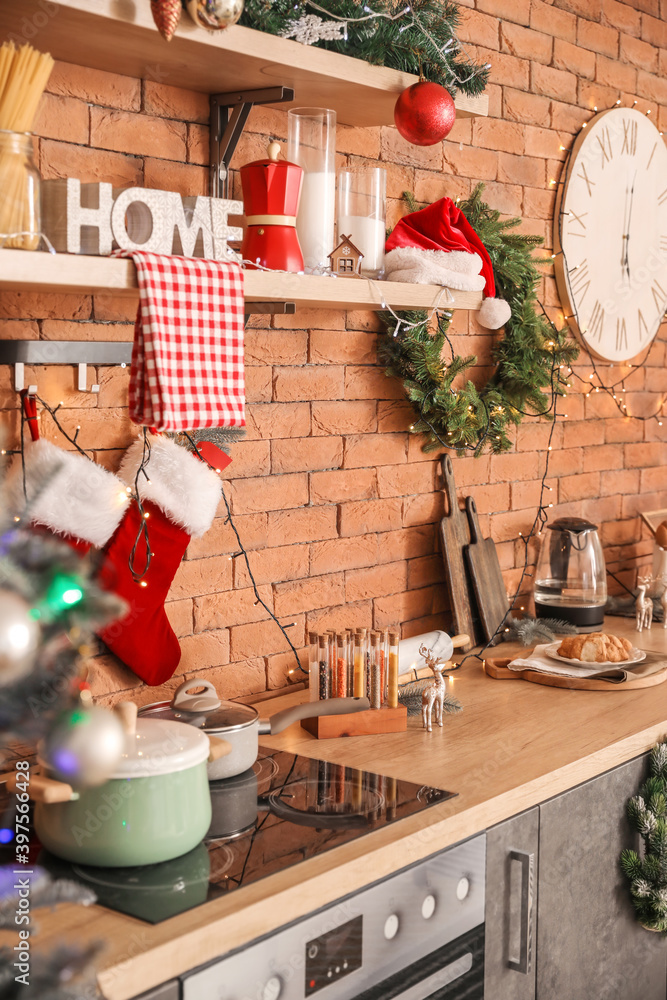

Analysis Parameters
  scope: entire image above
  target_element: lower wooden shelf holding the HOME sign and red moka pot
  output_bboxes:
[0,250,482,310]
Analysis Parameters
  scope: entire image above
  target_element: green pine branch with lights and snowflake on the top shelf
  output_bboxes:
[239,0,489,97]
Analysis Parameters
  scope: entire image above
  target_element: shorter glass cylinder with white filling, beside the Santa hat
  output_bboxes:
[337,167,387,278]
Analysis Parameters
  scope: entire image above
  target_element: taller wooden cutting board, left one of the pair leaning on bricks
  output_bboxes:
[440,455,481,653]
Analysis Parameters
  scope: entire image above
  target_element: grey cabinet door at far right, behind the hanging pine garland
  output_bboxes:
[536,754,667,1000]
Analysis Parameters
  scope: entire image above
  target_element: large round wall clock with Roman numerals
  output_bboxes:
[554,108,667,362]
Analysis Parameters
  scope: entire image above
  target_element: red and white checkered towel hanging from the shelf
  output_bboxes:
[115,250,245,431]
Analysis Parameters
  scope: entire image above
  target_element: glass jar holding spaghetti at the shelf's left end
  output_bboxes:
[0,129,42,250]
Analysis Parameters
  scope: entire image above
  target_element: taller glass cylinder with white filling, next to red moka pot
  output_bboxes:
[287,108,336,274]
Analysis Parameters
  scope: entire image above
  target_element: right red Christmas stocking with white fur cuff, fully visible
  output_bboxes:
[98,437,221,685]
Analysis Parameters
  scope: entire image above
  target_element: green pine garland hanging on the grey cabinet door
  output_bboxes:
[621,743,667,932]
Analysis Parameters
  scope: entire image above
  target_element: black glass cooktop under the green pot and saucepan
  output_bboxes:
[0,747,455,923]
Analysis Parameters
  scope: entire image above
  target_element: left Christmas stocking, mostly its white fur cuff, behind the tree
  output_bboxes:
[4,439,129,555]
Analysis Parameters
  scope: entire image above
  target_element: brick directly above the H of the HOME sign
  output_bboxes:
[40,139,143,187]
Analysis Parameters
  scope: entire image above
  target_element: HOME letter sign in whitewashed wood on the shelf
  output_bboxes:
[42,178,243,260]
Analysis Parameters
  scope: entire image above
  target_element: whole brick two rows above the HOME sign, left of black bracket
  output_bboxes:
[90,107,186,161]
